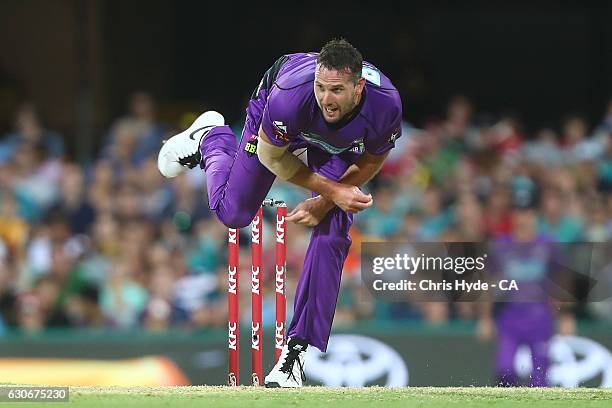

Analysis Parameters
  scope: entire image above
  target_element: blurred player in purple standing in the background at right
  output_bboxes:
[479,188,574,387]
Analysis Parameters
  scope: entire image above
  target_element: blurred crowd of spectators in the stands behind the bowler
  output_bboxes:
[0,92,612,332]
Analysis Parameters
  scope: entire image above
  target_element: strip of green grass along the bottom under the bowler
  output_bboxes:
[16,386,612,408]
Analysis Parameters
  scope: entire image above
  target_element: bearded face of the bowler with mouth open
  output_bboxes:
[314,65,365,123]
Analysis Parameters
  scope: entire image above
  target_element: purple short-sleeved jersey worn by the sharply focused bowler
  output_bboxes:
[254,53,402,155]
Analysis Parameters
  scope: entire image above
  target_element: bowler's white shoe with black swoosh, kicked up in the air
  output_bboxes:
[157,111,225,178]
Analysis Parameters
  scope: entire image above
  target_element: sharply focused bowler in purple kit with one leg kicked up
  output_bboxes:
[158,40,402,387]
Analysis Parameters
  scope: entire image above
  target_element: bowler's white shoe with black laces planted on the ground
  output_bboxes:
[264,339,308,388]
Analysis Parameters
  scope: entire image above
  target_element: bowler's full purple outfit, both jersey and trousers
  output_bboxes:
[200,53,402,351]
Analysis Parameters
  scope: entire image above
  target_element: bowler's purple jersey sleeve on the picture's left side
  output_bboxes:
[261,88,300,146]
